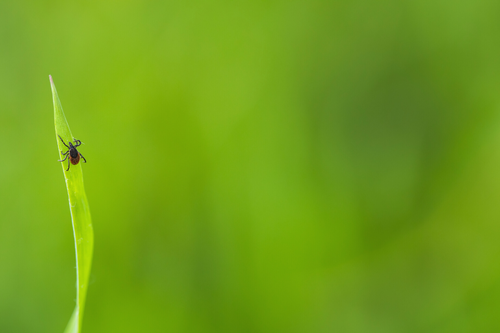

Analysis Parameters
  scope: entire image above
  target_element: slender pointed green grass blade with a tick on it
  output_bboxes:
[49,75,94,333]
